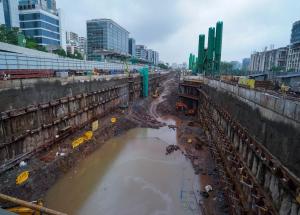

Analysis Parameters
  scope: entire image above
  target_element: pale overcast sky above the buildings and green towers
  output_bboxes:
[56,0,300,63]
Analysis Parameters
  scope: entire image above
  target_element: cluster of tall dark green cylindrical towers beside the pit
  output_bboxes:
[189,21,223,76]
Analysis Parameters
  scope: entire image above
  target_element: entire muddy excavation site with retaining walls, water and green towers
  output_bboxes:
[0,19,300,215]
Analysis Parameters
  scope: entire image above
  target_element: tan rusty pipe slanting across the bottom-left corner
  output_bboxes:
[0,193,67,215]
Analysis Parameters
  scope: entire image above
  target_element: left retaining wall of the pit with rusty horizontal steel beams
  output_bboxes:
[0,74,166,170]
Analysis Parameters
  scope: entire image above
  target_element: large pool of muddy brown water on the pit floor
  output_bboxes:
[45,119,200,215]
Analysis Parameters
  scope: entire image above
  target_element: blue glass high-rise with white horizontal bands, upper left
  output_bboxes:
[19,0,62,47]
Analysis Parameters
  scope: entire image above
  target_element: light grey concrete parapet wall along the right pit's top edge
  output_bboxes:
[206,80,300,128]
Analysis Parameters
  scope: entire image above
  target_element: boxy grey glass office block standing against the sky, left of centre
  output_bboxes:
[87,19,129,60]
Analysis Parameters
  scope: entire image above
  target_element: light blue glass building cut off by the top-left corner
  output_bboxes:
[0,0,20,28]
